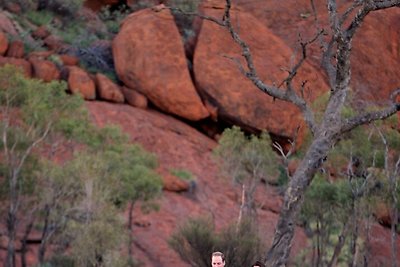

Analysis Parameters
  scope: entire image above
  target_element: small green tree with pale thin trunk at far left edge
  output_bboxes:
[0,67,82,267]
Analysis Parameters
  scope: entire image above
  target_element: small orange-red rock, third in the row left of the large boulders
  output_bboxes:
[68,66,96,100]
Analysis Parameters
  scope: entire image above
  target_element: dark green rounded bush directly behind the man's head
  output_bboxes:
[169,217,263,267]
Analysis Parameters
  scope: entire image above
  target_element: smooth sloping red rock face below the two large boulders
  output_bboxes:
[87,101,307,267]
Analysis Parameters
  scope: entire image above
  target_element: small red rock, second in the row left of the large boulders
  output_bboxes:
[96,73,125,103]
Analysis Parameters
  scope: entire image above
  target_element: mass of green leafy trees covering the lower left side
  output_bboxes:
[0,66,161,266]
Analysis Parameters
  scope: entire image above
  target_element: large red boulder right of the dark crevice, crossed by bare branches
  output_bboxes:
[194,1,327,143]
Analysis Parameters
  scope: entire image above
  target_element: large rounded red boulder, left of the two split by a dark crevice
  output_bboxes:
[112,6,209,121]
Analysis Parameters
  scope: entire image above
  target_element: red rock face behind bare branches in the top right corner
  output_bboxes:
[234,0,400,102]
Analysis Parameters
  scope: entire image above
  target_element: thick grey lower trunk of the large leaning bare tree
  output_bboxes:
[266,135,336,267]
